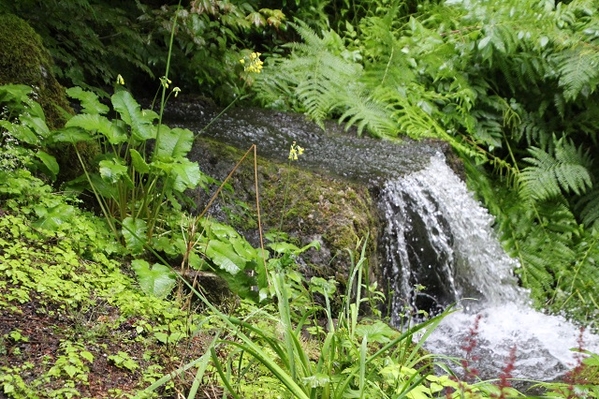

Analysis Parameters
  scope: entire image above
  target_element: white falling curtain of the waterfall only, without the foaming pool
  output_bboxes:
[379,154,525,324]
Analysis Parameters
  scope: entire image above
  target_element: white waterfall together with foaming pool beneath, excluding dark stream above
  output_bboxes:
[379,155,599,380]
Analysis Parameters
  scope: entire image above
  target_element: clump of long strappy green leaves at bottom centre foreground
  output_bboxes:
[206,241,460,398]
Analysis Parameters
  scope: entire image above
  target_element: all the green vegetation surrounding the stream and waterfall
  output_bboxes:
[0,0,599,399]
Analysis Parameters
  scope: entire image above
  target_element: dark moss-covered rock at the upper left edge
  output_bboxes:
[0,13,72,128]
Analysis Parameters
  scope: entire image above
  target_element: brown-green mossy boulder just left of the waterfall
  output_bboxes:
[190,138,377,300]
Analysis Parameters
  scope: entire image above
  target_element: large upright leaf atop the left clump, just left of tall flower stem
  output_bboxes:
[111,90,156,141]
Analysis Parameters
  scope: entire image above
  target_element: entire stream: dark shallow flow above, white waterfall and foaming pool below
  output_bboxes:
[167,103,599,380]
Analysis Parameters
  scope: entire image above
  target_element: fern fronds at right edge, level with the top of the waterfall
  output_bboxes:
[520,138,593,201]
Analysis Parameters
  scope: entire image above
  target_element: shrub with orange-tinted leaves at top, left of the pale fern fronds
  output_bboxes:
[141,1,285,105]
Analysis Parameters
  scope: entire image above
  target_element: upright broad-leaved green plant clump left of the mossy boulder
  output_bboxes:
[52,88,202,250]
